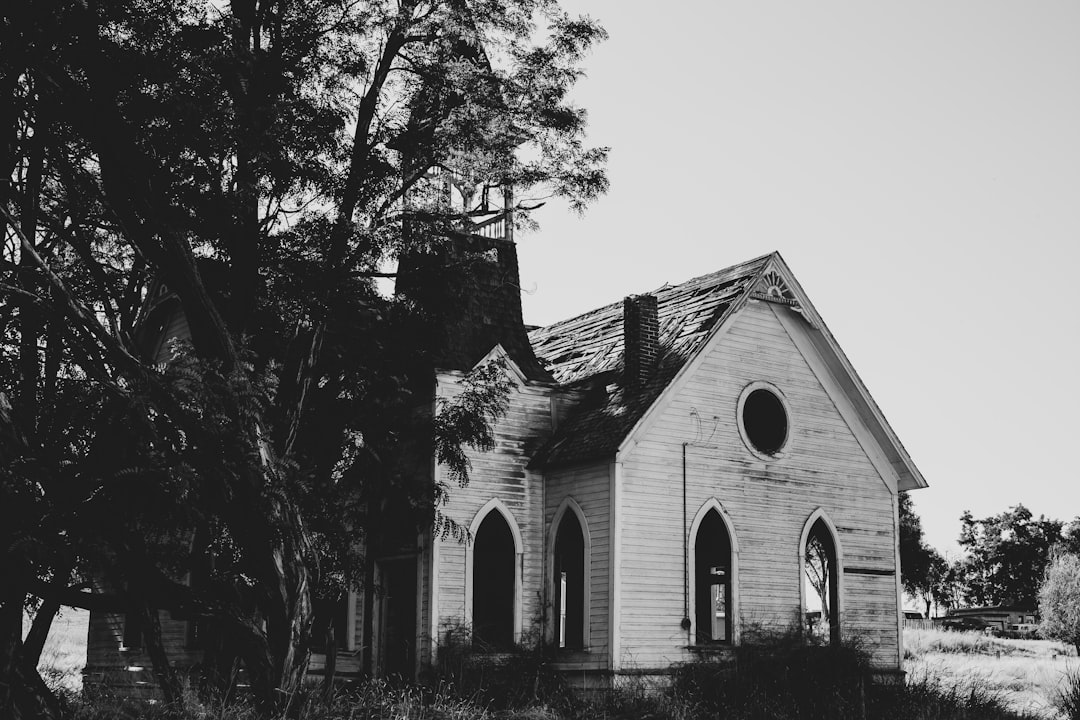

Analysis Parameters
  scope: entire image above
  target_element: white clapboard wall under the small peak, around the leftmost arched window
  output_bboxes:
[426,373,552,642]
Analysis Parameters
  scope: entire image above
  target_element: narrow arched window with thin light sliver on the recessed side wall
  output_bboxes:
[553,511,585,650]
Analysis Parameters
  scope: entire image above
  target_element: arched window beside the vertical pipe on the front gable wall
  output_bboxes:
[693,510,732,643]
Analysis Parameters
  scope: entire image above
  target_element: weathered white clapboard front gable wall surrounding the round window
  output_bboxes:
[618,302,900,669]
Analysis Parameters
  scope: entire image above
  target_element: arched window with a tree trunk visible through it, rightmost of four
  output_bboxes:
[802,517,840,644]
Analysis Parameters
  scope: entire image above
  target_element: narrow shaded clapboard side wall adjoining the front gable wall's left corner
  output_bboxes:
[544,462,612,670]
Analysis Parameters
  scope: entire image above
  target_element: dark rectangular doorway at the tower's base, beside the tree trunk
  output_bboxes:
[379,557,417,680]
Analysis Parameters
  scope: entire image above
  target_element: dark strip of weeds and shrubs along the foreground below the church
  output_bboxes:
[52,664,1054,720]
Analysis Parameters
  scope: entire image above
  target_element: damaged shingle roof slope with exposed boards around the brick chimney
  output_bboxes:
[529,255,773,465]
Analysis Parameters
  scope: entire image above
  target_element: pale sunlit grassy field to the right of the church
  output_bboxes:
[904,629,1080,718]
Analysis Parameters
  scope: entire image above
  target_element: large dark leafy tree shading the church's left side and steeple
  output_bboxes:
[0,0,606,716]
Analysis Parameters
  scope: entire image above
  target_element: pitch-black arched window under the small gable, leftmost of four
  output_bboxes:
[472,510,516,649]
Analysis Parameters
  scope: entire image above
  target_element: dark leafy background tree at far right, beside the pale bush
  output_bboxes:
[960,505,1062,608]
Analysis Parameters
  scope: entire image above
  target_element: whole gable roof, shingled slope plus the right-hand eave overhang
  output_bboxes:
[529,253,927,489]
